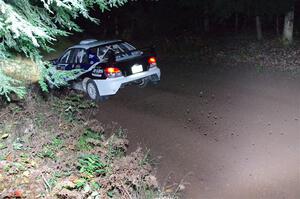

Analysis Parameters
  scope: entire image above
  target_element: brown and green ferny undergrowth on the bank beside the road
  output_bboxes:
[0,93,183,199]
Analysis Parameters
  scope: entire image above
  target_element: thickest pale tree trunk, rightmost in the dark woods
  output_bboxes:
[283,10,294,44]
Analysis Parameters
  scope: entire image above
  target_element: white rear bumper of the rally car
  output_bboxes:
[94,67,160,96]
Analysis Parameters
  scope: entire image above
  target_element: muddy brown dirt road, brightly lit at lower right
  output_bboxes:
[97,61,300,199]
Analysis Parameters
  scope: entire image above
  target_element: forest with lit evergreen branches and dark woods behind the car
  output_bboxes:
[0,0,298,97]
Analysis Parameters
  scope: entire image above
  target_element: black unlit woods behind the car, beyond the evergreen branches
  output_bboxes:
[76,0,300,41]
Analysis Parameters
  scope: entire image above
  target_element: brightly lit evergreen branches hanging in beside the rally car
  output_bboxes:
[0,0,127,99]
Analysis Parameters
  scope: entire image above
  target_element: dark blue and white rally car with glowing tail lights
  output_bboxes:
[52,39,161,101]
